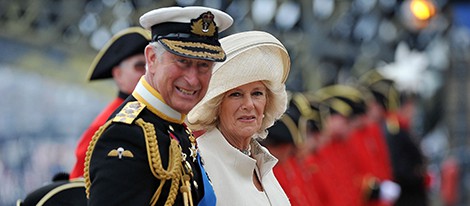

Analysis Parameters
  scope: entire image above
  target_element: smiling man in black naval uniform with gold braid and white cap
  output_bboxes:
[84,7,233,205]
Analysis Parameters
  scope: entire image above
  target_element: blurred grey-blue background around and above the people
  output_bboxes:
[0,0,470,205]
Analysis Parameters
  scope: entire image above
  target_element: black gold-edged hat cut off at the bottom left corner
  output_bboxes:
[16,173,87,206]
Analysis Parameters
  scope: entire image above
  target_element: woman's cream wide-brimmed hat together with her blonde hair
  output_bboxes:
[187,31,290,137]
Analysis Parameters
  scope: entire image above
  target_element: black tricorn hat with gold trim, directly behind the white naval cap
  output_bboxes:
[88,27,151,81]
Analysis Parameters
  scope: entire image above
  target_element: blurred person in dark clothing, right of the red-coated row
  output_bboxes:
[361,69,429,206]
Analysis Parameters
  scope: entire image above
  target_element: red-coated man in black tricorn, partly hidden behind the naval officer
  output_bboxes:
[70,27,150,179]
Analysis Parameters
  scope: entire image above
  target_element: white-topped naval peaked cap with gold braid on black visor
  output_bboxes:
[140,6,233,62]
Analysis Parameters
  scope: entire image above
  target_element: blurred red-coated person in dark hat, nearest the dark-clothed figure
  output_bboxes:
[316,84,400,205]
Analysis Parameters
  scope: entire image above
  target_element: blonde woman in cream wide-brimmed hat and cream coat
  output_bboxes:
[187,31,290,206]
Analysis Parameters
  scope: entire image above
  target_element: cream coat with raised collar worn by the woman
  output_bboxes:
[197,129,290,206]
